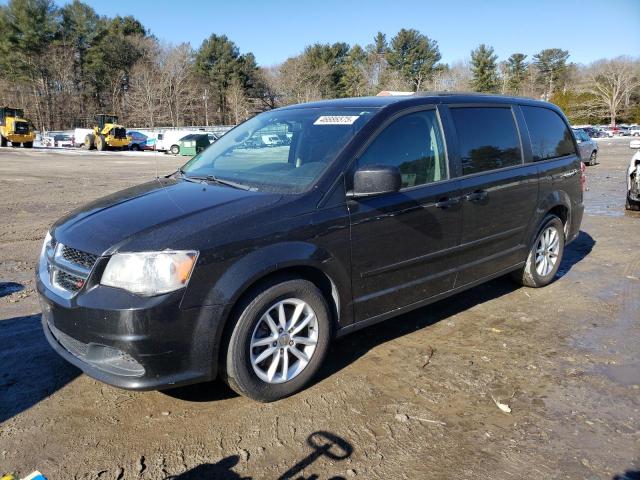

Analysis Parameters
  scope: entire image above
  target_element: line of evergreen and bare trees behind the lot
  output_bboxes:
[0,0,640,130]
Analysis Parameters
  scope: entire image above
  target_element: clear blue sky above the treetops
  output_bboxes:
[48,0,640,66]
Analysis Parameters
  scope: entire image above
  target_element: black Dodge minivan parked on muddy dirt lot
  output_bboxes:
[36,94,584,401]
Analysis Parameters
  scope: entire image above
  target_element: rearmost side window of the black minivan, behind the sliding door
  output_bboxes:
[521,106,576,162]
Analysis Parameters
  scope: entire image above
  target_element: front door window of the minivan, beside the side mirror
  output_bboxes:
[358,110,447,188]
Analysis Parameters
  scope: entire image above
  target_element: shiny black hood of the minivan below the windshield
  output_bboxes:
[51,178,281,255]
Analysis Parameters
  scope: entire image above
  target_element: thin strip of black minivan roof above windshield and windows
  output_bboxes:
[283,92,552,109]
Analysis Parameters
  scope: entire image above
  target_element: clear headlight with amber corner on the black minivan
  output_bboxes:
[100,250,198,295]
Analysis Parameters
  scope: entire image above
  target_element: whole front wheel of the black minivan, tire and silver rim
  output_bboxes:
[225,279,331,402]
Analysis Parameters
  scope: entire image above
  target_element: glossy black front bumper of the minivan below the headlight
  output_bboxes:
[36,276,221,390]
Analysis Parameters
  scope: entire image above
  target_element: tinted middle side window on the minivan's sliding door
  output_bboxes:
[451,107,522,175]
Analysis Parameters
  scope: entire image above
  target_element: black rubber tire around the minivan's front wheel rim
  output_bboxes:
[222,278,332,402]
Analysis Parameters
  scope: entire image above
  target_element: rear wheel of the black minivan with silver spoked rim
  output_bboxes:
[512,215,565,288]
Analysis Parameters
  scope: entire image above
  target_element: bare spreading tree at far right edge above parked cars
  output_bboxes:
[583,57,640,125]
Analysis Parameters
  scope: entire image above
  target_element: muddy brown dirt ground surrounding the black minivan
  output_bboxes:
[0,139,640,480]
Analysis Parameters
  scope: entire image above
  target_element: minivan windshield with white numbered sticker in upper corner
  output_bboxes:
[182,108,377,193]
